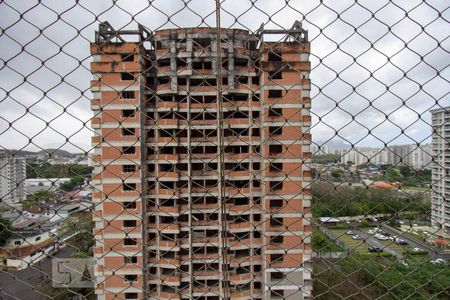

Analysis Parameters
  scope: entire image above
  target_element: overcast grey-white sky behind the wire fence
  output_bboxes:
[0,0,450,152]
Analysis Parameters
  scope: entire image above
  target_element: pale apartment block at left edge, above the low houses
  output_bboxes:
[0,151,26,206]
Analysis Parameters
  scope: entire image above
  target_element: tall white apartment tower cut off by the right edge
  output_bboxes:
[431,107,450,230]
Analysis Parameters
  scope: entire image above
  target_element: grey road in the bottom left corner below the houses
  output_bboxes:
[0,246,76,300]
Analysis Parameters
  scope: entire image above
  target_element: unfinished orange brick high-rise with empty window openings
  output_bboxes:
[91,22,312,300]
